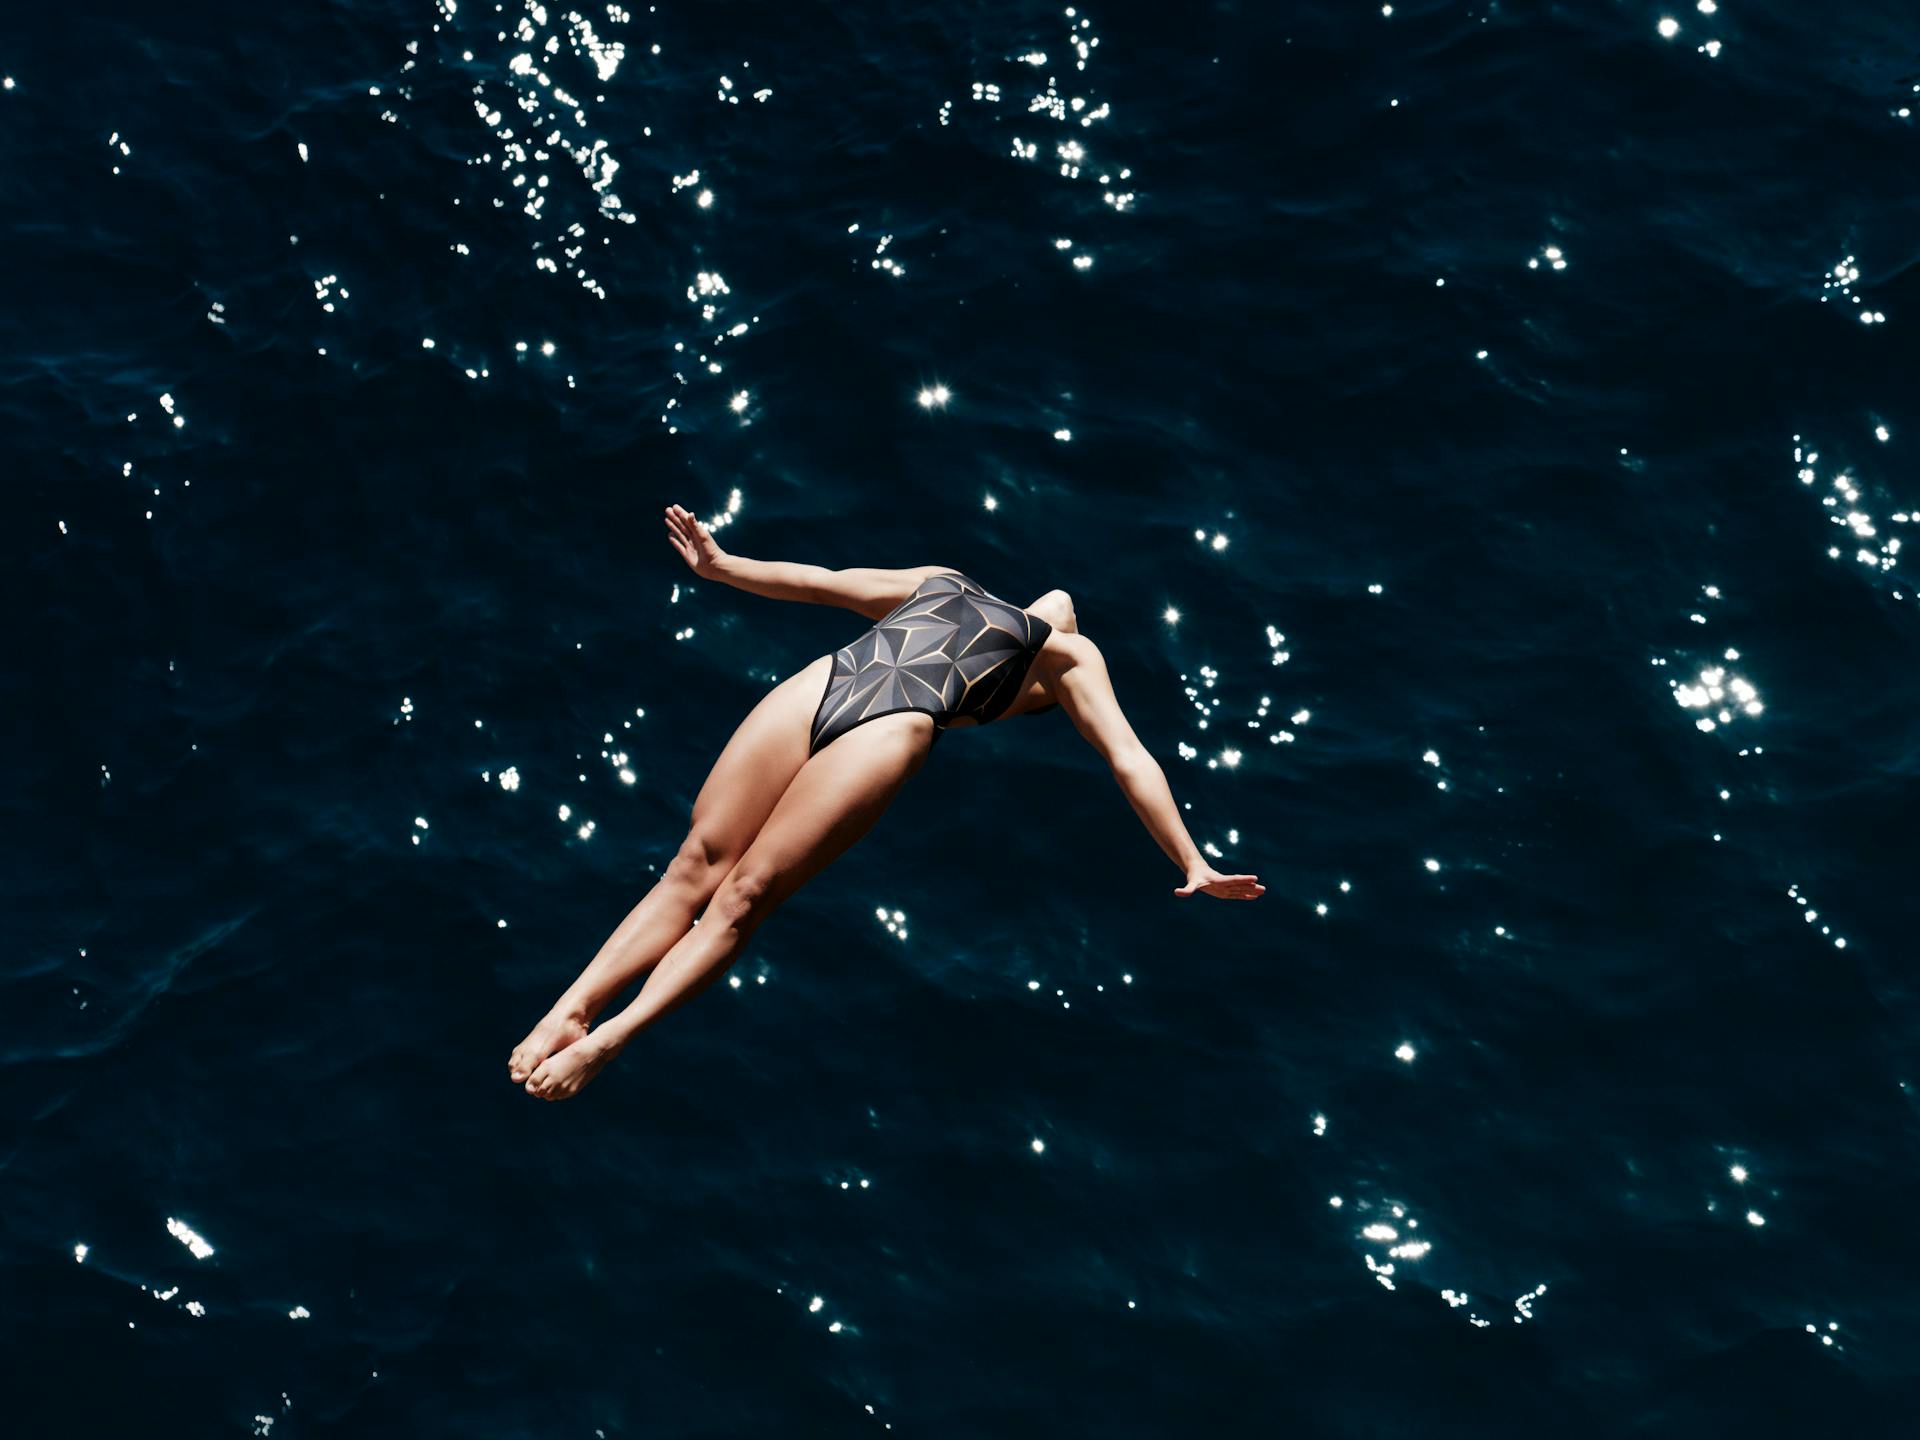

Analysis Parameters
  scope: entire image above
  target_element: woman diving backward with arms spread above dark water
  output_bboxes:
[507,505,1265,1100]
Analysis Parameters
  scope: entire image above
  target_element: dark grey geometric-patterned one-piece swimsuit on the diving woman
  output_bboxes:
[806,570,1054,755]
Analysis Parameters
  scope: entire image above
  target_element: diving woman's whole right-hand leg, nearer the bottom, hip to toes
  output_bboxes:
[526,712,933,1100]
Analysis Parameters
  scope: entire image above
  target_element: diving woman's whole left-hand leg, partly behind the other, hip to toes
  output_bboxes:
[507,655,833,1085]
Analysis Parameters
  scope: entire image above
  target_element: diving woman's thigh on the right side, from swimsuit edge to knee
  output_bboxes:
[722,710,933,914]
